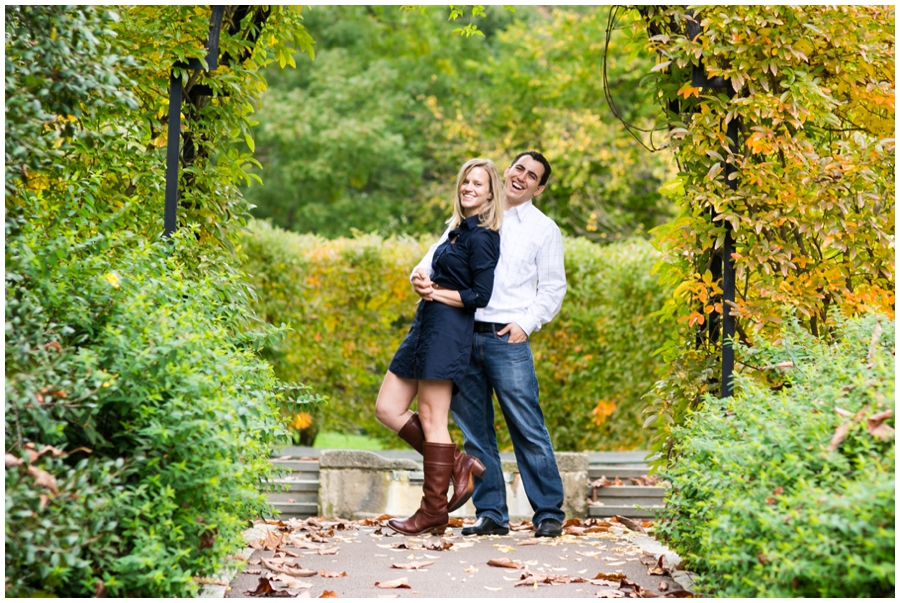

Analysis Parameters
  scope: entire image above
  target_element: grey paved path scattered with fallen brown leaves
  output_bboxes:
[203,518,691,598]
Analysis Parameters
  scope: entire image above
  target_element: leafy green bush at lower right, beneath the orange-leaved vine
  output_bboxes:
[659,314,895,597]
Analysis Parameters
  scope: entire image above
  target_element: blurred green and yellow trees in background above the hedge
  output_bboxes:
[246,6,672,240]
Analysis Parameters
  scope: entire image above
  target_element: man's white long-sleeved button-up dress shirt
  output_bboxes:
[410,200,566,335]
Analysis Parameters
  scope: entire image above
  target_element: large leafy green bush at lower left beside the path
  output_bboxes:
[5,232,298,596]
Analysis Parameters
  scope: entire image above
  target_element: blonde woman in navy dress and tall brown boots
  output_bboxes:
[375,159,504,536]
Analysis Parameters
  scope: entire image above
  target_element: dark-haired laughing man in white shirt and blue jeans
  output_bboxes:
[411,151,566,537]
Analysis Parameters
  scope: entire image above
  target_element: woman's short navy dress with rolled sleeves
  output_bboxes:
[390,216,500,393]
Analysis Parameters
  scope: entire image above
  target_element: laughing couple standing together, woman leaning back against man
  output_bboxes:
[375,151,566,537]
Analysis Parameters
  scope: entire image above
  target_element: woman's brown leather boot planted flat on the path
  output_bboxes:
[388,442,456,536]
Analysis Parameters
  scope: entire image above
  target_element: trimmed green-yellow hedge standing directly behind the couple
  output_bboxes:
[242,221,668,450]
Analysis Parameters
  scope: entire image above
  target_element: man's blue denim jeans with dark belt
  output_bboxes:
[450,333,566,526]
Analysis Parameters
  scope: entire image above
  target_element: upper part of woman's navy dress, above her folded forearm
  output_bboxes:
[431,216,500,312]
